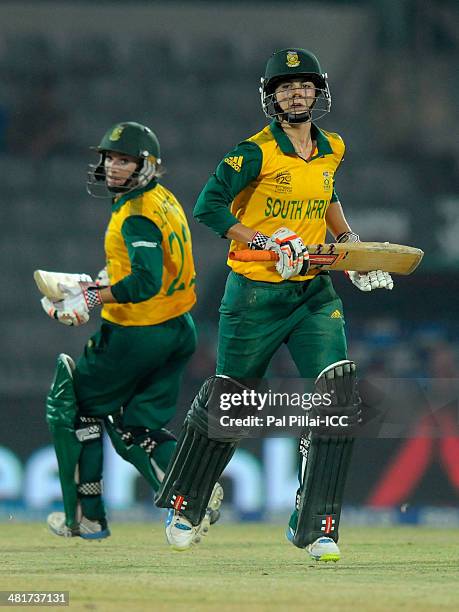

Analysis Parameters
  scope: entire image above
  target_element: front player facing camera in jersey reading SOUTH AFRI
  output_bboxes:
[157,49,393,561]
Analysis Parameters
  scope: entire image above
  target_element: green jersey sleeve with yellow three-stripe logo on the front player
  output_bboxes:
[193,142,263,238]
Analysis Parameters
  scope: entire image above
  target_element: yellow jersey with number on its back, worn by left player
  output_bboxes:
[102,180,196,326]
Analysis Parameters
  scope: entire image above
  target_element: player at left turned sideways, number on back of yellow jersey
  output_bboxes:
[42,122,223,539]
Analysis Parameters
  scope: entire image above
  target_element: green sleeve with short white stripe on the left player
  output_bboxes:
[111,215,163,304]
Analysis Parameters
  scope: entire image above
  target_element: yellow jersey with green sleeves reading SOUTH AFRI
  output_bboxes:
[194,121,345,282]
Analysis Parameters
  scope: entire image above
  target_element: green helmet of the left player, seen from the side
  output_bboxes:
[87,121,161,197]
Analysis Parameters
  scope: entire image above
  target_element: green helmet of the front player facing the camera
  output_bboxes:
[260,48,331,123]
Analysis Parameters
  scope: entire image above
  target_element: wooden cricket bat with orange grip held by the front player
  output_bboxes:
[229,242,424,275]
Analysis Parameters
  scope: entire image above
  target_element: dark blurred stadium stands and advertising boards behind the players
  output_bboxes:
[0,0,459,524]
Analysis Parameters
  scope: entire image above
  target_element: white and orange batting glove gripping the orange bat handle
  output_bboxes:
[264,227,309,280]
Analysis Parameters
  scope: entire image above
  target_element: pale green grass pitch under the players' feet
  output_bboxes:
[0,522,459,612]
